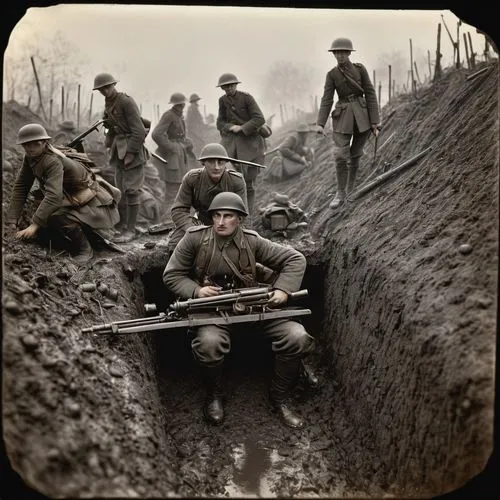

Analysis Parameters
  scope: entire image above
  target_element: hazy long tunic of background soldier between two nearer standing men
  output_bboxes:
[151,109,192,183]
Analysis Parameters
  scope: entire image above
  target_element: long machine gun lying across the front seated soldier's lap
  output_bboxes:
[82,287,311,335]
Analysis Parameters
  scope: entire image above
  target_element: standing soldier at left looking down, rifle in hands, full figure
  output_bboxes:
[94,73,148,243]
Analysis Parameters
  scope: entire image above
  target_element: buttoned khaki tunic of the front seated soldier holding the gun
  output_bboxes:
[163,226,306,299]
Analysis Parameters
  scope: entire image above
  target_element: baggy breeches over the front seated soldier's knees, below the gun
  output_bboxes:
[191,319,315,366]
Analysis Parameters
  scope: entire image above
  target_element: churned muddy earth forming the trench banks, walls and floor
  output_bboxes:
[2,59,499,498]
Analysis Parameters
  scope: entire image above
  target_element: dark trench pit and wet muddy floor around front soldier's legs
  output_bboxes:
[141,264,358,497]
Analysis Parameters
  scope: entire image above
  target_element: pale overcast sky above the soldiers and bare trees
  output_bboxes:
[4,4,490,124]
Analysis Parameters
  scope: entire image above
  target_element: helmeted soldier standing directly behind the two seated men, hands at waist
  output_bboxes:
[217,73,271,215]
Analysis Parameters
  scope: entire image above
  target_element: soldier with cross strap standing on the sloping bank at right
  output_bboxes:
[316,38,380,209]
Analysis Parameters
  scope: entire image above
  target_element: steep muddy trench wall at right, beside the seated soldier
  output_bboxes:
[318,114,498,495]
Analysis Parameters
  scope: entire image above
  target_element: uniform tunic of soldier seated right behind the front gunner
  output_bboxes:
[169,167,247,248]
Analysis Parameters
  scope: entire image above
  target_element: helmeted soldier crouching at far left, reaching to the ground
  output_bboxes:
[6,123,120,264]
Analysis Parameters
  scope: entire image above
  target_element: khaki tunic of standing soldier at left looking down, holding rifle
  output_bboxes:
[103,92,148,170]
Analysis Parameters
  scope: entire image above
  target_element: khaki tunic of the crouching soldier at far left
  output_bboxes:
[7,147,120,229]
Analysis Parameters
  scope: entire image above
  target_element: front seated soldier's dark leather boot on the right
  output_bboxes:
[269,354,305,429]
